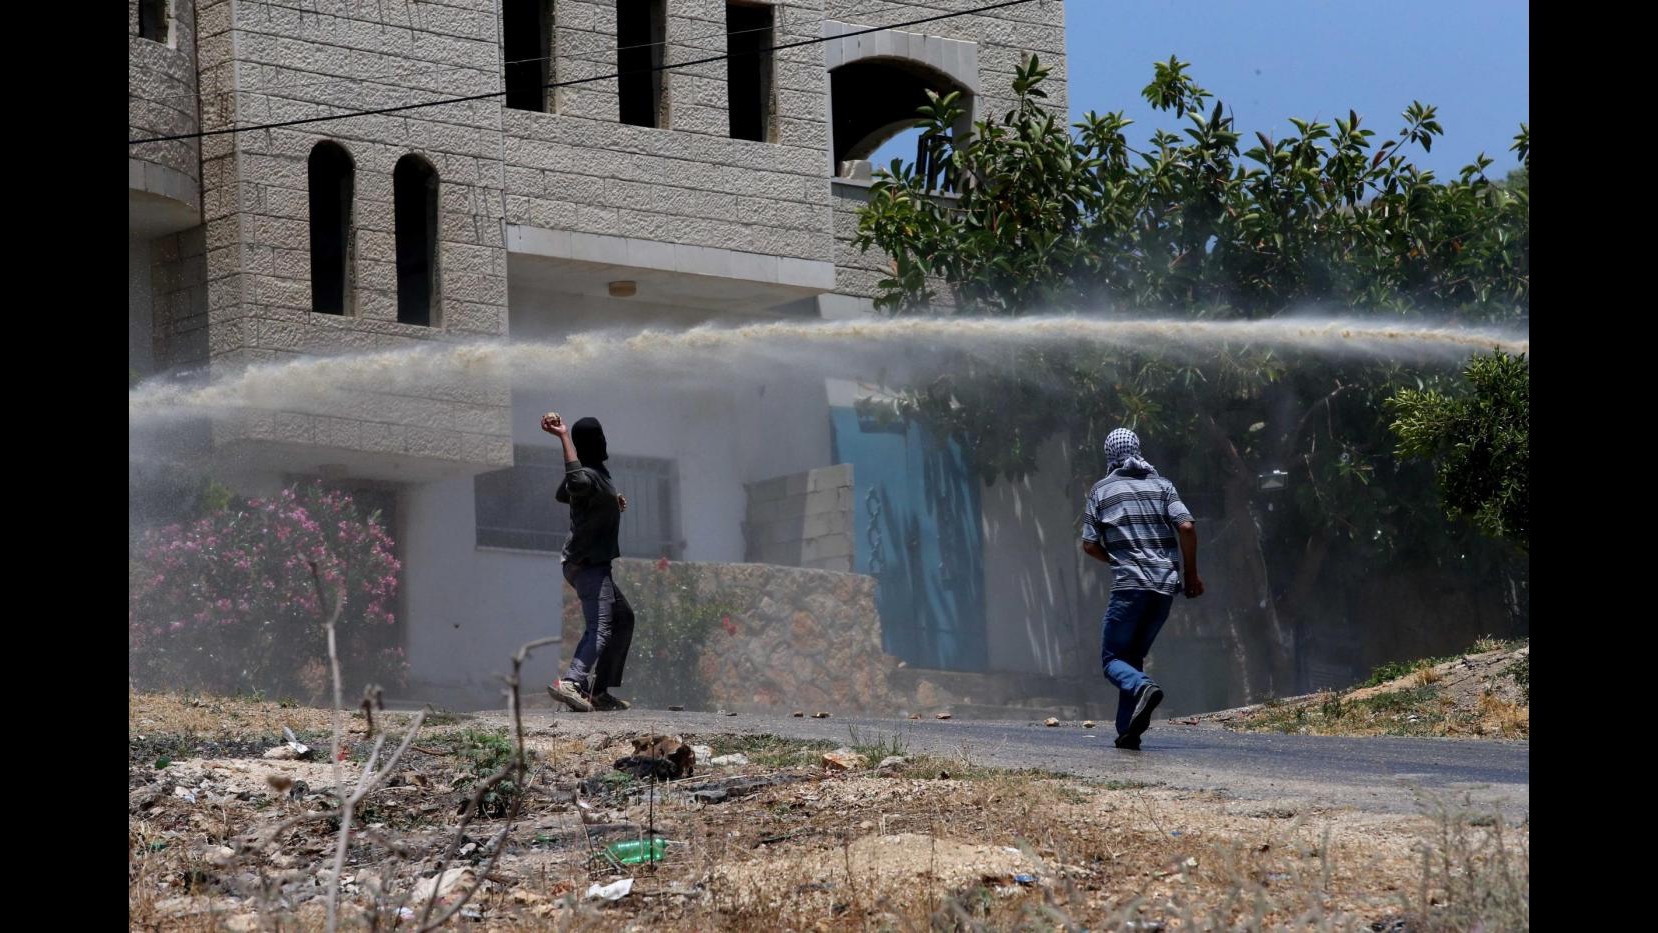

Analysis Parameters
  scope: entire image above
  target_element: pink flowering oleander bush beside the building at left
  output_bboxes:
[128,486,406,696]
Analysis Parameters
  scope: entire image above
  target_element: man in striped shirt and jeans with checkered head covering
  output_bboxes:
[1083,428,1204,751]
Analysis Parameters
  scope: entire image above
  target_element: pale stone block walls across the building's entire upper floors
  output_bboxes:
[129,0,1064,467]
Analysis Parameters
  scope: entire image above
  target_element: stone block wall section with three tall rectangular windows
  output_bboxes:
[501,0,832,262]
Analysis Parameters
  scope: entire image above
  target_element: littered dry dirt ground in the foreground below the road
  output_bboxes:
[128,694,1529,931]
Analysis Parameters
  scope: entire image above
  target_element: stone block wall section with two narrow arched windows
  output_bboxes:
[184,0,512,469]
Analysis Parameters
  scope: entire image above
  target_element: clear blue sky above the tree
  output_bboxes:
[875,0,1530,177]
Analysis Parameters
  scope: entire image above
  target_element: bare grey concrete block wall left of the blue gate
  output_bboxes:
[743,464,857,573]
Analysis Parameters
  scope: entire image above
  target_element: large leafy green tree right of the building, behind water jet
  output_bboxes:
[856,58,1530,694]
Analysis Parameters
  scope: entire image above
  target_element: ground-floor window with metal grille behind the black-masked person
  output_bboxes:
[473,444,681,560]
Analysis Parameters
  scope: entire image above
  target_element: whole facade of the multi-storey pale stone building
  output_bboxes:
[128,0,1074,706]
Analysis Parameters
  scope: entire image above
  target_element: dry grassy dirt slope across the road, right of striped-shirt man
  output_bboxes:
[1177,641,1532,739]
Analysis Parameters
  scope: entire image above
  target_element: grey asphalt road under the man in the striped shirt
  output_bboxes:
[484,709,1530,820]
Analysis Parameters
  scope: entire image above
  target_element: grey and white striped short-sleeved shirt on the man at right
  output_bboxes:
[1083,469,1192,595]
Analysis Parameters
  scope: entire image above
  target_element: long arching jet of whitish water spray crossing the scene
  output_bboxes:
[128,317,1530,428]
